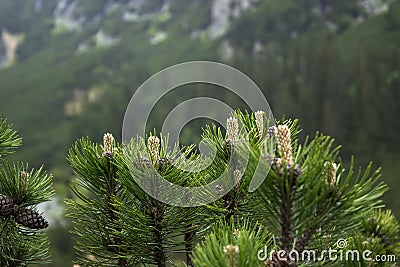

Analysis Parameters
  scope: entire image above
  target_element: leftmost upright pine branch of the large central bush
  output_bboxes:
[67,137,137,267]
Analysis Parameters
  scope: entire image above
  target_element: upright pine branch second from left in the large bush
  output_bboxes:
[113,138,204,266]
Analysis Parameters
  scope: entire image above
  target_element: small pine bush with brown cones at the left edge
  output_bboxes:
[0,117,54,266]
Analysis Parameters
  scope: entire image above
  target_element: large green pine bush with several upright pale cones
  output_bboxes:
[67,111,400,267]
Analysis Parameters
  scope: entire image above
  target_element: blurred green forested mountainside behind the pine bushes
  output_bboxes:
[0,0,400,266]
